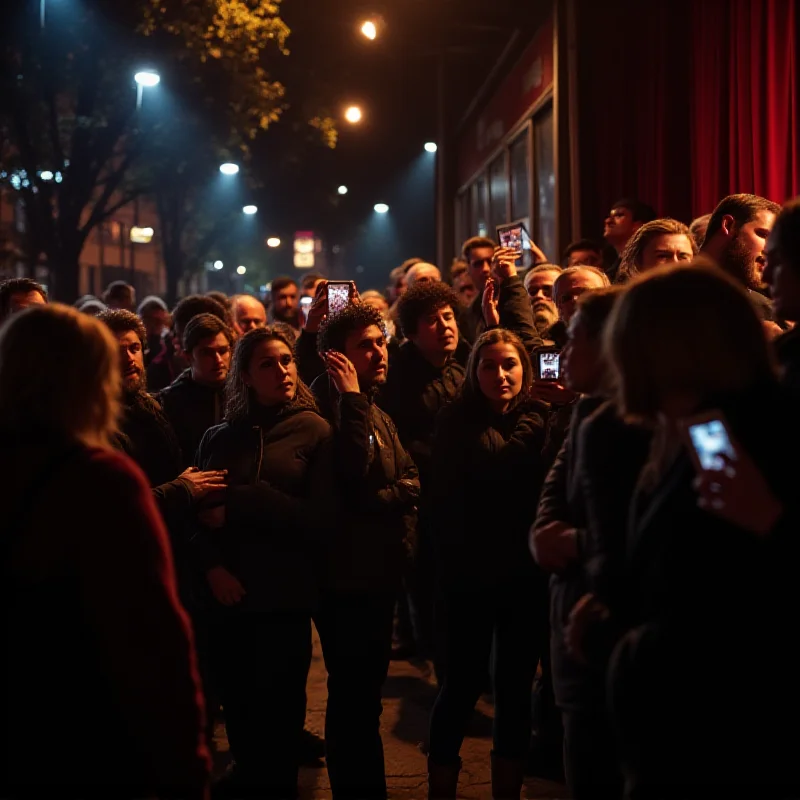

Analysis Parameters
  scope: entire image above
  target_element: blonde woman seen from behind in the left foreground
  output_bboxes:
[0,305,209,798]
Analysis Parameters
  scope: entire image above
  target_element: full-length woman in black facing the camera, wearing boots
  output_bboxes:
[428,329,547,800]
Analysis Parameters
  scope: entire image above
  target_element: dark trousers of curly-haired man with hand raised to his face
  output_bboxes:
[314,591,397,800]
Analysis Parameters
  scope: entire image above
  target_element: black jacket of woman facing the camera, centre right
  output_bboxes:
[431,400,546,589]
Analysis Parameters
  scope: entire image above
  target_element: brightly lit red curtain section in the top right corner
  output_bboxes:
[691,0,800,214]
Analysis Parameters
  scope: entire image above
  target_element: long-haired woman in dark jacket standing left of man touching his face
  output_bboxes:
[195,328,331,800]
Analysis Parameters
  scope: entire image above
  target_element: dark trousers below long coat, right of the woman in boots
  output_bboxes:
[561,704,623,800]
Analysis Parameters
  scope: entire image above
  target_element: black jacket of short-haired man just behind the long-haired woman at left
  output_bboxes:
[157,369,225,469]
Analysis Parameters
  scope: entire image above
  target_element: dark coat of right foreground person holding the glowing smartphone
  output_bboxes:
[609,385,800,797]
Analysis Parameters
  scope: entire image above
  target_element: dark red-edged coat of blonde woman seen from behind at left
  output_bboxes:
[0,437,210,800]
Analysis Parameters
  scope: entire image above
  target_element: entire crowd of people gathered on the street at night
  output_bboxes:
[0,194,800,800]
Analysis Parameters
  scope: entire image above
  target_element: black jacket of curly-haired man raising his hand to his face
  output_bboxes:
[311,375,419,591]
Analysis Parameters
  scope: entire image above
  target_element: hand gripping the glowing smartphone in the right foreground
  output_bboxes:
[694,454,783,536]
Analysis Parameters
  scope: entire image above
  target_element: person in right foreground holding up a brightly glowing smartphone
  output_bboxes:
[592,266,800,797]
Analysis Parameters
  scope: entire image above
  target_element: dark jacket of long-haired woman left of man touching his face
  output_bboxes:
[193,402,334,611]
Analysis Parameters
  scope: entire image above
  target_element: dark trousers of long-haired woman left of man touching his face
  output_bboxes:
[211,610,311,800]
